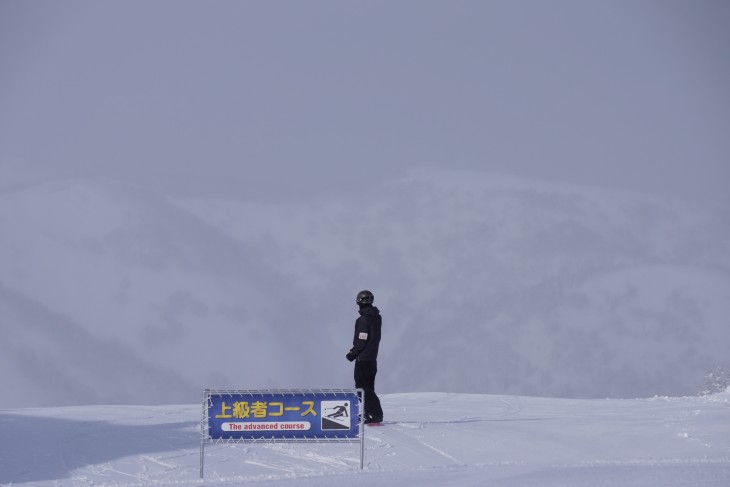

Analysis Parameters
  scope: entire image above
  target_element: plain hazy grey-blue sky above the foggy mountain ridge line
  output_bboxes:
[0,0,730,201]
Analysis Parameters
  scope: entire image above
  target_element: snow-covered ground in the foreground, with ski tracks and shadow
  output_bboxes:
[0,391,730,487]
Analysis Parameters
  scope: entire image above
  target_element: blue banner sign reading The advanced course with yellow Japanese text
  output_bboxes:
[207,390,360,441]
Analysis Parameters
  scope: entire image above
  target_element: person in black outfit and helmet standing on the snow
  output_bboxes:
[347,290,383,424]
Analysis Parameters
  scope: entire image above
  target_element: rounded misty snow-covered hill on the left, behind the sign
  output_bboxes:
[0,181,324,407]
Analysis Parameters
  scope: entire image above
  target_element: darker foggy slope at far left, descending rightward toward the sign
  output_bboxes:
[0,280,191,407]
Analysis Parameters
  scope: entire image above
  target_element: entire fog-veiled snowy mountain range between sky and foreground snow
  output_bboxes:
[0,170,730,407]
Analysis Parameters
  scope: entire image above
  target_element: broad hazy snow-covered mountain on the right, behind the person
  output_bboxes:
[169,171,730,397]
